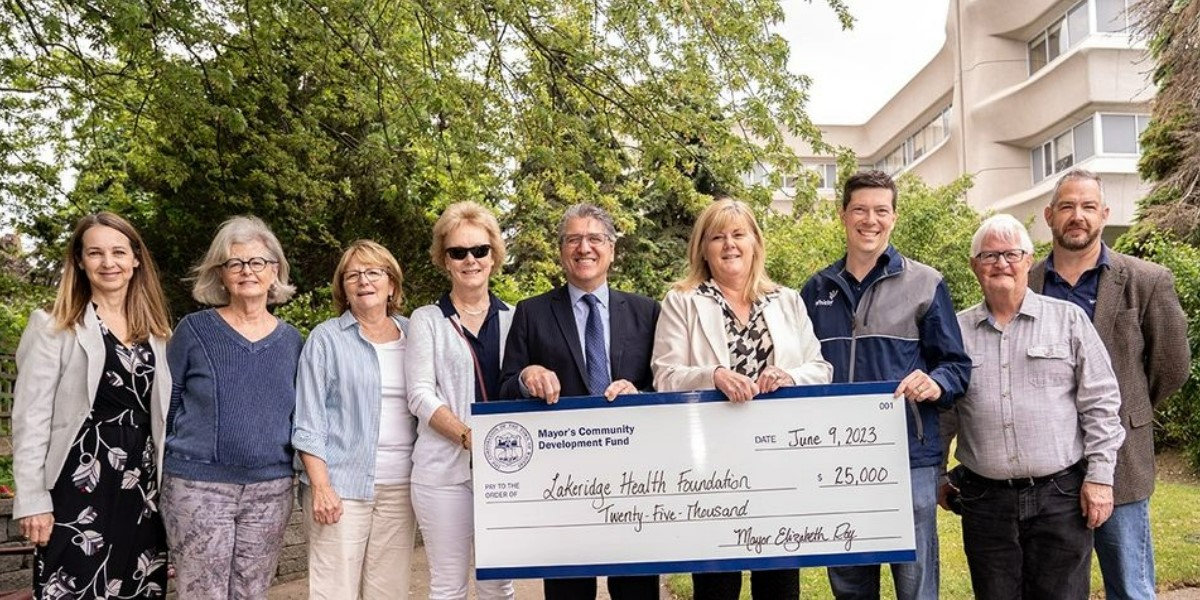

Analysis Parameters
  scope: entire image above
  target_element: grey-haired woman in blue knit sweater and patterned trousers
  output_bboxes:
[162,217,304,599]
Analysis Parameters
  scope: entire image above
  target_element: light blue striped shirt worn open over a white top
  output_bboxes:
[292,311,415,500]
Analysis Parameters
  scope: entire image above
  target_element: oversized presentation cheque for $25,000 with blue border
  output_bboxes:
[470,383,916,580]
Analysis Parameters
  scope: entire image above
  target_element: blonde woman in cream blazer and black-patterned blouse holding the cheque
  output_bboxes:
[652,198,833,600]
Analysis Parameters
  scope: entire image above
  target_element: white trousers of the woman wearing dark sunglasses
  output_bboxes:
[413,481,514,600]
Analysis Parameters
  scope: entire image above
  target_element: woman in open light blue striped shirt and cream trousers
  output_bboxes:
[292,240,416,600]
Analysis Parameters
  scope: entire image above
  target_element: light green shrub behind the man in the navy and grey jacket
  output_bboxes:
[766,175,982,310]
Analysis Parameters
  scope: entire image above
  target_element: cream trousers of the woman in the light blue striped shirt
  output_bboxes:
[300,484,416,600]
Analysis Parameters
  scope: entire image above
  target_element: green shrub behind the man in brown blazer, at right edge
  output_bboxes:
[1116,232,1200,469]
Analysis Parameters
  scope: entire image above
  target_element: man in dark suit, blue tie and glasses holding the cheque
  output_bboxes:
[500,204,659,600]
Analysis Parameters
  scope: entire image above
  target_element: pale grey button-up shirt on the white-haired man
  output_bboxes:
[955,290,1124,485]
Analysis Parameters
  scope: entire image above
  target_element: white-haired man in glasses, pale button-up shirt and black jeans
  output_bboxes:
[948,215,1124,600]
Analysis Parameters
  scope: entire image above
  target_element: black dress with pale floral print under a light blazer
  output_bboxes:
[34,323,167,599]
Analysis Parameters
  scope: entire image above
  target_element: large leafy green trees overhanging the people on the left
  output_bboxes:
[0,0,850,313]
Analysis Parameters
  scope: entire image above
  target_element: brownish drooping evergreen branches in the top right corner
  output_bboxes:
[1132,0,1200,245]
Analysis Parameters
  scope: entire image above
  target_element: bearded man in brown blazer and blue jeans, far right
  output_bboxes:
[1030,169,1190,599]
